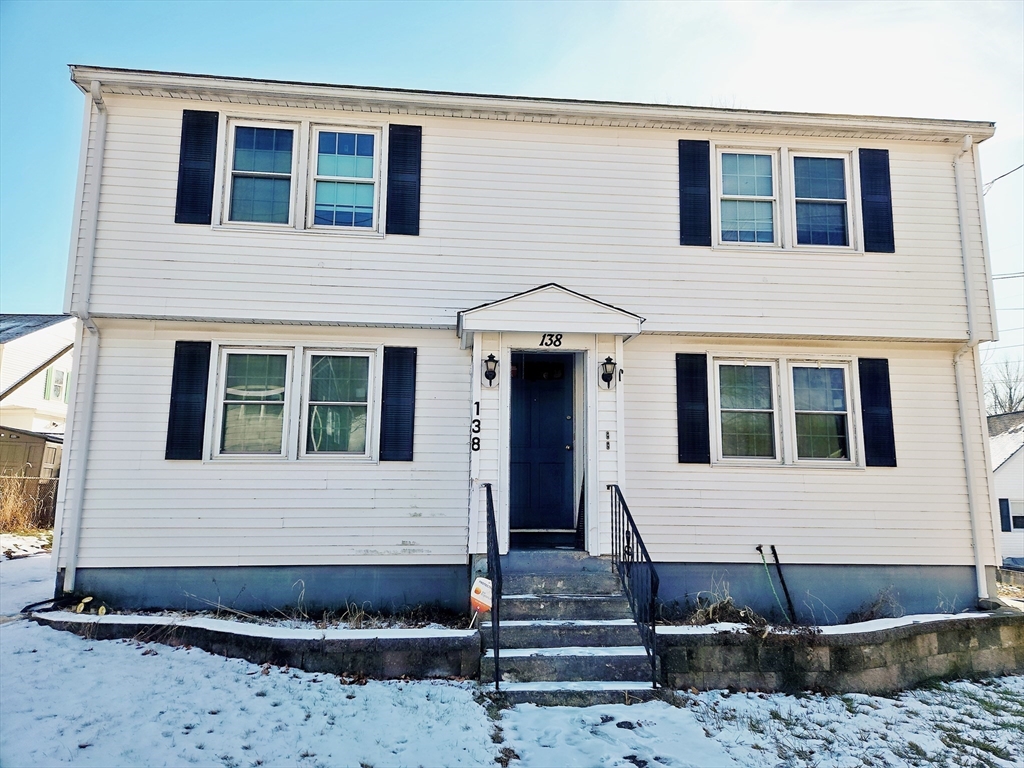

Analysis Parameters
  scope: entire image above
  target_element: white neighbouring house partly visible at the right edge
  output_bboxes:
[988,411,1024,565]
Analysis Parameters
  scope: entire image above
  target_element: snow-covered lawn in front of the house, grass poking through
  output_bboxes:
[0,555,1024,768]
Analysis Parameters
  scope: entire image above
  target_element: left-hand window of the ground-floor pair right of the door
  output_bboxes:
[717,364,777,459]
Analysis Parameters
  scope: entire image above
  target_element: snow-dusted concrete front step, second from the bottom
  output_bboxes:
[480,645,651,683]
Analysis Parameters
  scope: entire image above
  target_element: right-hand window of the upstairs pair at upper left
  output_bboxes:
[313,130,378,228]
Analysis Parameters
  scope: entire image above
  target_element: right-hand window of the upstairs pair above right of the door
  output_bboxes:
[793,157,850,246]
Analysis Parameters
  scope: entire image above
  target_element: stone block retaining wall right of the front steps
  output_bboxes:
[657,613,1024,693]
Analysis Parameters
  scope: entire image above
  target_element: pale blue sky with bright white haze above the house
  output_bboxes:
[0,0,1024,358]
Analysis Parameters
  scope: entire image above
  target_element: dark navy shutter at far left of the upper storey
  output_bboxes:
[174,110,220,224]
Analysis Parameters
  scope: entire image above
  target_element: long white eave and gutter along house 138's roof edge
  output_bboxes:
[71,65,995,142]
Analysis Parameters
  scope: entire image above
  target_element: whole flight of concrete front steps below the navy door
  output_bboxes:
[480,550,658,707]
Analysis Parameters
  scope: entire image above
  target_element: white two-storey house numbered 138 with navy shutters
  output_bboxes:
[54,67,997,620]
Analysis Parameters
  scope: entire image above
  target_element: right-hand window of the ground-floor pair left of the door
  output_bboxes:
[305,352,371,455]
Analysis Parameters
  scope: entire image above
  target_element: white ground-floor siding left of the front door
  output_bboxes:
[57,322,470,567]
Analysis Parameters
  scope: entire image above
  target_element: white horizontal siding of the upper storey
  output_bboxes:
[76,95,991,340]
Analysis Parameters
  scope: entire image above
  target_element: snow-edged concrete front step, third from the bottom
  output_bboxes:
[480,618,640,648]
